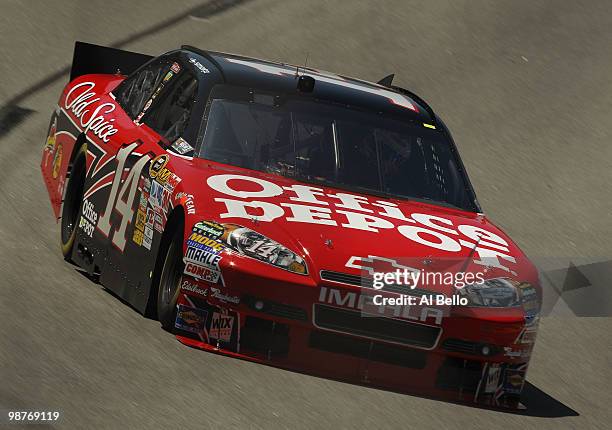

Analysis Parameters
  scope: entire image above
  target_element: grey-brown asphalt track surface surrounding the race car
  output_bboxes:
[0,0,612,429]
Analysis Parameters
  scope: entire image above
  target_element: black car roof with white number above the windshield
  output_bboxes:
[182,46,436,124]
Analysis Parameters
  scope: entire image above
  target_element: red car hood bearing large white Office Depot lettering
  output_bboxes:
[182,160,537,290]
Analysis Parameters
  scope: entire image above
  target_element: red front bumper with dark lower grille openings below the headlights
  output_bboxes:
[176,272,537,408]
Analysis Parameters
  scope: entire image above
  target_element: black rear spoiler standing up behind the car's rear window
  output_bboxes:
[70,42,153,81]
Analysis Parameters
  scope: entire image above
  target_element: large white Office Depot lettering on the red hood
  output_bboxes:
[206,174,516,275]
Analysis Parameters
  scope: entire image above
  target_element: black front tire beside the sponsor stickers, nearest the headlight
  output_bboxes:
[157,228,184,332]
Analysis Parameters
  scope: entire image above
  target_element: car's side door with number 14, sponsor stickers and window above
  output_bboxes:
[99,57,197,310]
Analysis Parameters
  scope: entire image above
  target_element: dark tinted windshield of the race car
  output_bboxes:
[199,90,474,210]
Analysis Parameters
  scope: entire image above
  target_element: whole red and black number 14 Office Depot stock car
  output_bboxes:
[41,42,541,408]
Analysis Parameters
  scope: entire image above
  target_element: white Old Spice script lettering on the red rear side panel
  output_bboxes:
[64,82,118,143]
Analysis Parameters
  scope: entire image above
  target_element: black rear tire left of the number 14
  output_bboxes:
[60,145,87,261]
